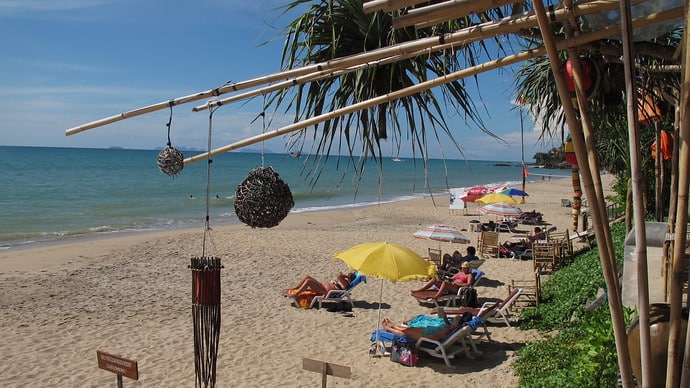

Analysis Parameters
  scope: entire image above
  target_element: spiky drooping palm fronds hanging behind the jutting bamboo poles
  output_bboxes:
[267,0,504,180]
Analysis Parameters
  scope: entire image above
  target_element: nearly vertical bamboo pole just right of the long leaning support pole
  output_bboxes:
[620,0,648,387]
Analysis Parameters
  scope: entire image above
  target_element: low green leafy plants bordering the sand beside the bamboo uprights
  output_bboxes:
[513,224,632,387]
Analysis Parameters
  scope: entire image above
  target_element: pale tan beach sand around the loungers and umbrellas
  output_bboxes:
[0,175,612,387]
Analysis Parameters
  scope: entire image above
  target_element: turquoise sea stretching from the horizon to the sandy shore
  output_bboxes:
[0,146,566,250]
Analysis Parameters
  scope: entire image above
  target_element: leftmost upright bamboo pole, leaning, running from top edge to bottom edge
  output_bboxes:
[534,1,632,387]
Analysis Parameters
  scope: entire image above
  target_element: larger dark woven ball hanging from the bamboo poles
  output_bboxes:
[235,167,295,228]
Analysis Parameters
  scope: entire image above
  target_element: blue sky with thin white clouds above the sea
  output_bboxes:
[0,0,560,162]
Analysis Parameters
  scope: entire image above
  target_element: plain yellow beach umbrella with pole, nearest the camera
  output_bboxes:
[333,242,436,357]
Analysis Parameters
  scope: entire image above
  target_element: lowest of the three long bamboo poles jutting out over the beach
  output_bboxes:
[184,7,683,164]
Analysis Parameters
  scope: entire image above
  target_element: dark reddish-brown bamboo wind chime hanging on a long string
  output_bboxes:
[189,106,223,387]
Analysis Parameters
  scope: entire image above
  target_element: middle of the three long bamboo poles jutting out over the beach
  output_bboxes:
[192,0,645,112]
